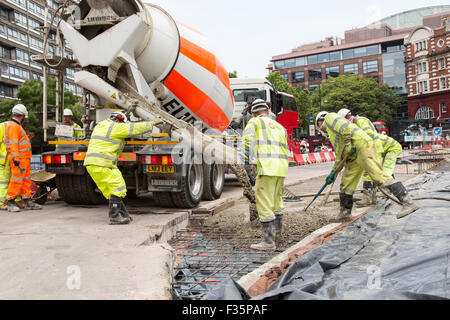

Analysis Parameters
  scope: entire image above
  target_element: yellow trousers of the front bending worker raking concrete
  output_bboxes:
[340,141,395,195]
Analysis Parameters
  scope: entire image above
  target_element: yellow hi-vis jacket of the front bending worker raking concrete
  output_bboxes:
[324,112,372,164]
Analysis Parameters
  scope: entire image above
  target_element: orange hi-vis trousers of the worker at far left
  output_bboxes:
[6,158,32,201]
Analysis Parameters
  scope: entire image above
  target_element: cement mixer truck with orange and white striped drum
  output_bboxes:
[34,0,241,208]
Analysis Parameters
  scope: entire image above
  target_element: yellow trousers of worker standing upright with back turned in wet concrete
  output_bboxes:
[255,175,284,222]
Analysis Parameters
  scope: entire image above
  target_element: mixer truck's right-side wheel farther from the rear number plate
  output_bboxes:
[202,163,225,201]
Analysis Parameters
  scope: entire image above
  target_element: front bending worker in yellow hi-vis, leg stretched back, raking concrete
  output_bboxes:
[315,111,419,222]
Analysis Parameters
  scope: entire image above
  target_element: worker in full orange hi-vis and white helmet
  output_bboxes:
[5,104,42,212]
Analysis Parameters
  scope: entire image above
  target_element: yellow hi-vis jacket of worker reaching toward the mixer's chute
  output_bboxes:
[84,119,153,169]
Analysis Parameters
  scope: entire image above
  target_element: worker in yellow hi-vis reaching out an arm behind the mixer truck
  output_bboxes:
[84,111,162,225]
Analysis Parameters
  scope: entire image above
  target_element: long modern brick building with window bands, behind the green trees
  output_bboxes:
[268,5,450,120]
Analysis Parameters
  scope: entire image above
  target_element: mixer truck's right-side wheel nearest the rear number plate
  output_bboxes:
[171,164,203,209]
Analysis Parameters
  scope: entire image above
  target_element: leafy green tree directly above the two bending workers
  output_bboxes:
[311,74,404,123]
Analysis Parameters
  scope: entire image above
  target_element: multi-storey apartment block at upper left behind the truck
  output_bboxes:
[0,0,82,100]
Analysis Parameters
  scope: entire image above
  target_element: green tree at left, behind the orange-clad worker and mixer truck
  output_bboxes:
[0,79,82,153]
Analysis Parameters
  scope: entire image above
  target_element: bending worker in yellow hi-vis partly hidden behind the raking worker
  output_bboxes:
[338,108,403,206]
